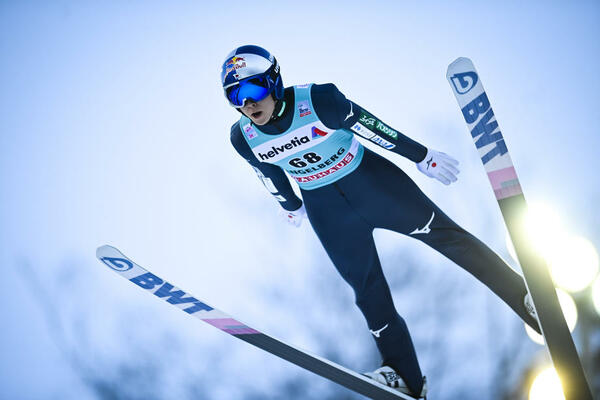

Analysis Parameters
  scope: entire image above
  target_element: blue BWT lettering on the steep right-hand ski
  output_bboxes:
[457,92,508,165]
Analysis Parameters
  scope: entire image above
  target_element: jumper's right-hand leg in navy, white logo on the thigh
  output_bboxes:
[351,152,540,332]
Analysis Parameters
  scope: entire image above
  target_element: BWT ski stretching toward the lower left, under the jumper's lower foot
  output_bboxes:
[96,245,414,400]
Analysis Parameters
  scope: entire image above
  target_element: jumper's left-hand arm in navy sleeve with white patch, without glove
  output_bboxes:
[231,122,302,211]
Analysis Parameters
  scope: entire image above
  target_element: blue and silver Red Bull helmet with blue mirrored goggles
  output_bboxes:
[221,45,283,108]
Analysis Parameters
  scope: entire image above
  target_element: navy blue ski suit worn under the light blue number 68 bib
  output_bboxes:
[231,84,539,393]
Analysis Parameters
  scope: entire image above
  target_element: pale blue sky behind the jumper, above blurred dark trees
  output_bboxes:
[0,1,600,399]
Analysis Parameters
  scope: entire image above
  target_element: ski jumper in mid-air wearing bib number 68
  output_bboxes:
[221,45,539,398]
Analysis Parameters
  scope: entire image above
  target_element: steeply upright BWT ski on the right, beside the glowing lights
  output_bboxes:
[446,57,592,400]
